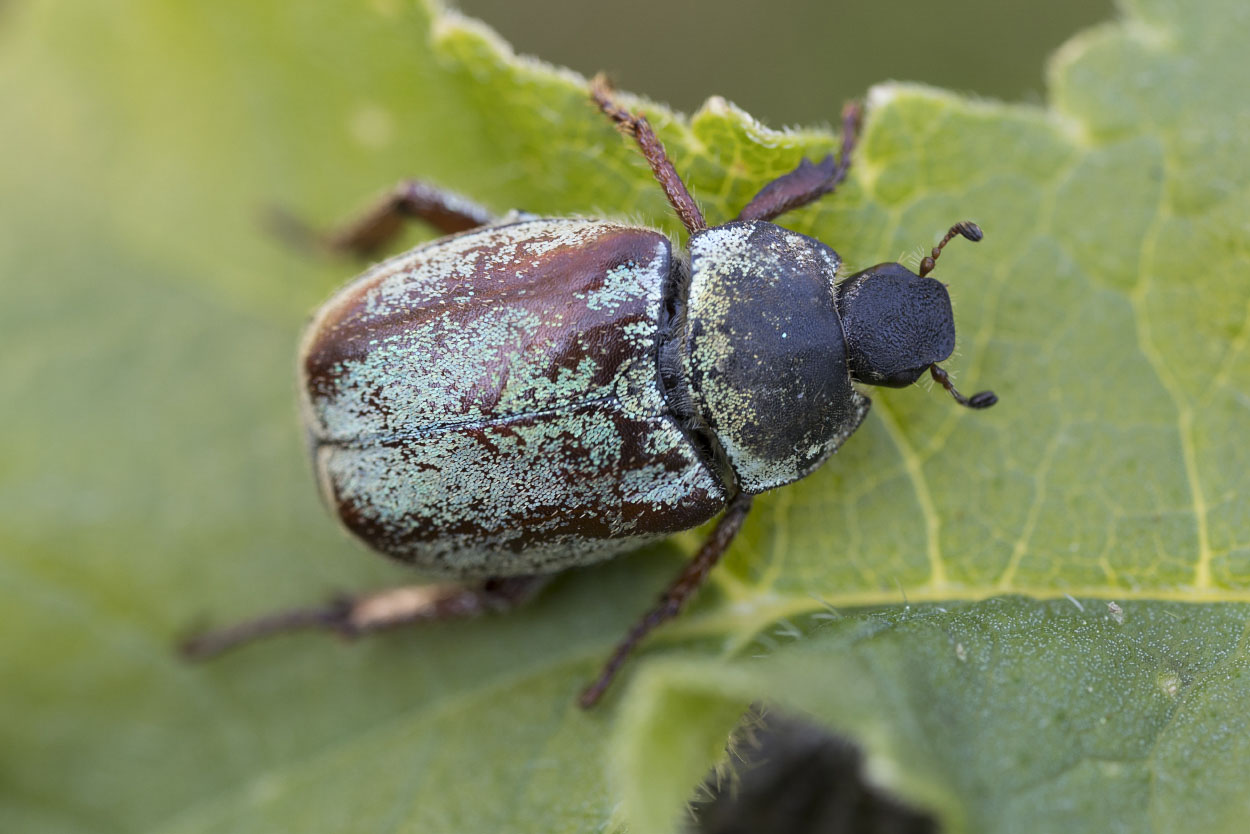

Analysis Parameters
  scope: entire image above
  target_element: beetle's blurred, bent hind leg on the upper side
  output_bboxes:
[270,180,495,256]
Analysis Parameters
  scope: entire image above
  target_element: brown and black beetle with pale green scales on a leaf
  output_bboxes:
[184,76,996,706]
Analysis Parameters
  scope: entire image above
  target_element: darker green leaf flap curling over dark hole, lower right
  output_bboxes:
[630,598,1250,833]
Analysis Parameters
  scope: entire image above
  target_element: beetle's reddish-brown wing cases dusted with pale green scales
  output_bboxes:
[301,219,726,578]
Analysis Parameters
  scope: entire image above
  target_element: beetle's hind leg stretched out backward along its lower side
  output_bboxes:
[180,576,550,660]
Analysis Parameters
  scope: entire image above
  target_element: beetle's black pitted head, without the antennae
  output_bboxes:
[838,264,955,388]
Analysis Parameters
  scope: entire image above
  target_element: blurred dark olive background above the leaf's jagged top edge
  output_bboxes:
[456,0,1114,122]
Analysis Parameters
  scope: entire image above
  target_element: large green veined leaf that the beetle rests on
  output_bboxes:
[0,0,1250,831]
